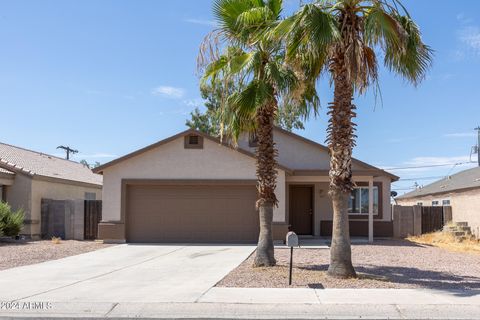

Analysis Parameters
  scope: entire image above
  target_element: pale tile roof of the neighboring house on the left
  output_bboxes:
[0,143,102,185]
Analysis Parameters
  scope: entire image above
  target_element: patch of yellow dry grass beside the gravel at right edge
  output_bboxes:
[407,231,480,254]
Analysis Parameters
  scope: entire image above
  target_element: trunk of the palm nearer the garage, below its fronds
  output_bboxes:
[254,101,278,267]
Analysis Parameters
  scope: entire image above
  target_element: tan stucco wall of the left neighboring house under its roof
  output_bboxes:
[29,179,102,236]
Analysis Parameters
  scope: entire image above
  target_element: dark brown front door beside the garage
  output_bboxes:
[289,185,313,235]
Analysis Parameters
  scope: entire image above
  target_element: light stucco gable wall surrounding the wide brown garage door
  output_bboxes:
[102,137,285,222]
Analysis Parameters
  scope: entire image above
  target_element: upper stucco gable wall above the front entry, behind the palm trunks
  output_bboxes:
[238,130,366,170]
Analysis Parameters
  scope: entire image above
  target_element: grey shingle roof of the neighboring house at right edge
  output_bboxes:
[397,167,480,199]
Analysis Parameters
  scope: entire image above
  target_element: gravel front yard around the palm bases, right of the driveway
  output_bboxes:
[217,240,480,290]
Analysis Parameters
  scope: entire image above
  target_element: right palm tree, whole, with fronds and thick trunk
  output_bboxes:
[282,0,432,277]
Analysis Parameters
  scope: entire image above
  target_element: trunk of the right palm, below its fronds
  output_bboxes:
[328,64,356,278]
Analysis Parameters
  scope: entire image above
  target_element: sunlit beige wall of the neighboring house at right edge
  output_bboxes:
[397,189,480,238]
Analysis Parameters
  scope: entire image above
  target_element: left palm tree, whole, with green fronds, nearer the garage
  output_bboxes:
[198,0,318,266]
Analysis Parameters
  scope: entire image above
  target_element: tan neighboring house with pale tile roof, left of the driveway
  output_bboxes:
[0,143,102,239]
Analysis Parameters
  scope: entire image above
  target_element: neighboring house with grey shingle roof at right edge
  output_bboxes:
[395,167,480,238]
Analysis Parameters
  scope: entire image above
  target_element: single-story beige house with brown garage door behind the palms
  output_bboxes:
[94,128,398,242]
